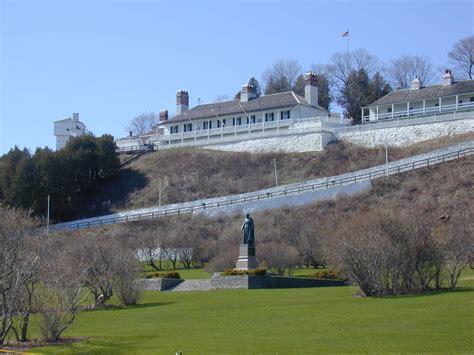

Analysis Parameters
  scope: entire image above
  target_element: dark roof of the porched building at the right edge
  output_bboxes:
[369,80,474,106]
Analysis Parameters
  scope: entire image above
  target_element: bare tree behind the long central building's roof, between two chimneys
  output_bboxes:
[262,59,302,94]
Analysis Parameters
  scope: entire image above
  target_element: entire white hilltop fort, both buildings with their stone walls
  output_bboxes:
[116,70,474,152]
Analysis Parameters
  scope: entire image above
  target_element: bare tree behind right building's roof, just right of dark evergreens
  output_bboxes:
[385,55,435,89]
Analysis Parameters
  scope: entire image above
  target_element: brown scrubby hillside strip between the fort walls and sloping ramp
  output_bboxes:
[77,133,474,221]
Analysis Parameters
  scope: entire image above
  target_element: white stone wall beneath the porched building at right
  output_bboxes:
[338,118,474,148]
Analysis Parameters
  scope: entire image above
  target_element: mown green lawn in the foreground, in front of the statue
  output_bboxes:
[24,272,474,354]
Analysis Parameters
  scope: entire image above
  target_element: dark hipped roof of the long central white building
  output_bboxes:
[161,91,326,124]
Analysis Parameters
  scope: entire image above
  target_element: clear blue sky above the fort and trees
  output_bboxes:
[0,0,474,154]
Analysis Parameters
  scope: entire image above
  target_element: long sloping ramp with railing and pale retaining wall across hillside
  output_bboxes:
[50,141,474,231]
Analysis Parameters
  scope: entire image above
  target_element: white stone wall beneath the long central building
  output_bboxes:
[202,132,327,153]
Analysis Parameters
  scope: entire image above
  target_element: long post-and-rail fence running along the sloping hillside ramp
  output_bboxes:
[50,142,474,231]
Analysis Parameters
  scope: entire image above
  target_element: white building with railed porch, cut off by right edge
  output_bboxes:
[362,70,474,122]
